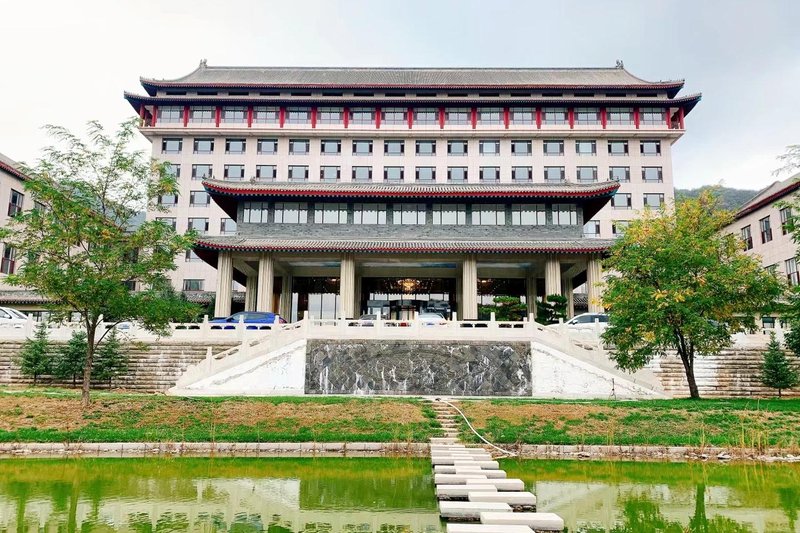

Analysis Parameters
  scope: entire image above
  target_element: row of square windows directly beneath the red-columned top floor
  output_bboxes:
[161,137,661,156]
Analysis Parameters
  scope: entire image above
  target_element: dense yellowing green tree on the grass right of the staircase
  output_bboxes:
[603,192,784,398]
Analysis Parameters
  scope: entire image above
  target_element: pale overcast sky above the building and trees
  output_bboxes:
[0,0,800,189]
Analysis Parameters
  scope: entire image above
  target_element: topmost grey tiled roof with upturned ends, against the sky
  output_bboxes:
[141,61,684,96]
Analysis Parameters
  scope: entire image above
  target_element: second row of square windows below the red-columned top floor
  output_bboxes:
[162,164,664,183]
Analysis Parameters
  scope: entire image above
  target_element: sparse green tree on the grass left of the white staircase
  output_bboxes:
[0,120,197,405]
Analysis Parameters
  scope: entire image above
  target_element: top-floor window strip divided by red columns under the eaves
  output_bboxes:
[148,106,669,127]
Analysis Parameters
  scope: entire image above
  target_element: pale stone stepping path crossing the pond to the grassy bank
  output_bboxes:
[430,401,564,533]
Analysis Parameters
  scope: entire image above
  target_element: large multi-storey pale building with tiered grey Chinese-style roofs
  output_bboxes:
[125,61,700,319]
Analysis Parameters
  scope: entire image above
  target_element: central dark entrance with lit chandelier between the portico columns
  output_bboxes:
[360,278,457,320]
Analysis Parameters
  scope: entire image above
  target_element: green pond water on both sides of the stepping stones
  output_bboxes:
[0,458,800,533]
